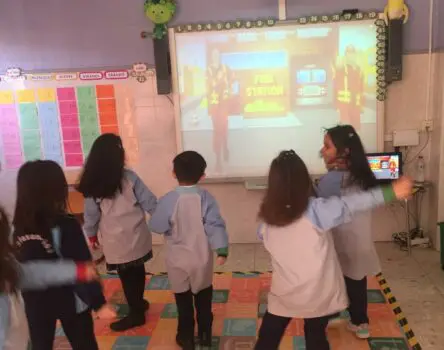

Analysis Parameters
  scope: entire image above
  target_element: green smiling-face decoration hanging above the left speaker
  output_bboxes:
[144,0,176,39]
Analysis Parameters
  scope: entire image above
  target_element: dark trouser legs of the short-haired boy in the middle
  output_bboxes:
[174,286,213,340]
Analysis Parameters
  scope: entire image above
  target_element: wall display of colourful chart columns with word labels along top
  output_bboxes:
[0,70,140,182]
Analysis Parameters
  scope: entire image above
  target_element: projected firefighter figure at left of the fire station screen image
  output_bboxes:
[207,48,233,171]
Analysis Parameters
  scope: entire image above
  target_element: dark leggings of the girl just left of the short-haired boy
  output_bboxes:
[117,264,145,316]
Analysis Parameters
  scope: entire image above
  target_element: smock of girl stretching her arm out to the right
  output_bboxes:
[258,187,394,318]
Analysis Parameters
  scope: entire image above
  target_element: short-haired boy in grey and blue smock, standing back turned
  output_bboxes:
[150,151,228,350]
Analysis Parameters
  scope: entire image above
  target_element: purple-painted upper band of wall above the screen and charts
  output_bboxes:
[0,0,444,72]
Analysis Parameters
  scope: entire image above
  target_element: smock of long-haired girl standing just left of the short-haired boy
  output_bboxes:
[83,169,157,264]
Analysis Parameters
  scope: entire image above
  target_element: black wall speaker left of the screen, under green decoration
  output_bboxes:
[153,36,171,95]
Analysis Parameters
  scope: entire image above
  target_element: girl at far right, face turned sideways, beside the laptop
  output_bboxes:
[318,125,381,339]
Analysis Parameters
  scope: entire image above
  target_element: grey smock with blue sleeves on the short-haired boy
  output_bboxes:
[149,186,228,294]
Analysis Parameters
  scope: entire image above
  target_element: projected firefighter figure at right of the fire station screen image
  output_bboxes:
[333,45,364,130]
